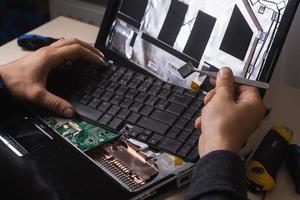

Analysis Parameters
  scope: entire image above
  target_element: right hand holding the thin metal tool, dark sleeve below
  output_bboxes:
[195,68,266,157]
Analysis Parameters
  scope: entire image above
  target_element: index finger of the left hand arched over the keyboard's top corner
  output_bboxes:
[50,44,104,68]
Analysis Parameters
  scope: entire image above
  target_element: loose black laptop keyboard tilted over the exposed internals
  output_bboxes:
[67,65,204,162]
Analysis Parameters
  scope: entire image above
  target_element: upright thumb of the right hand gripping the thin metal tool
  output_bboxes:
[216,67,235,98]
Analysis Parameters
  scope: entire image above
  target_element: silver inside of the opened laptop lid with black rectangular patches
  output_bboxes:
[105,0,291,88]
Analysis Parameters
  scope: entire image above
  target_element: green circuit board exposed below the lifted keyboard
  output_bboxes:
[44,118,118,151]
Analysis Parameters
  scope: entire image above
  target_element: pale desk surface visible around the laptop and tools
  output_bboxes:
[0,17,300,200]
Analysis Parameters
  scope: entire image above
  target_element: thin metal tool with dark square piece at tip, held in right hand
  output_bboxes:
[178,63,270,90]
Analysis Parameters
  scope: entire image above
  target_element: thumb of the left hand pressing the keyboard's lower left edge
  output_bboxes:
[33,88,75,118]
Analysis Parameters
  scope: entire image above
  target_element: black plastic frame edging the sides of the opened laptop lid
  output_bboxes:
[95,0,300,85]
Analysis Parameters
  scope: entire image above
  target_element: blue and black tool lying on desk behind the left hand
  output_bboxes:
[17,34,58,51]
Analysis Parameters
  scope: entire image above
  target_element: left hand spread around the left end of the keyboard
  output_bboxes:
[0,38,104,117]
